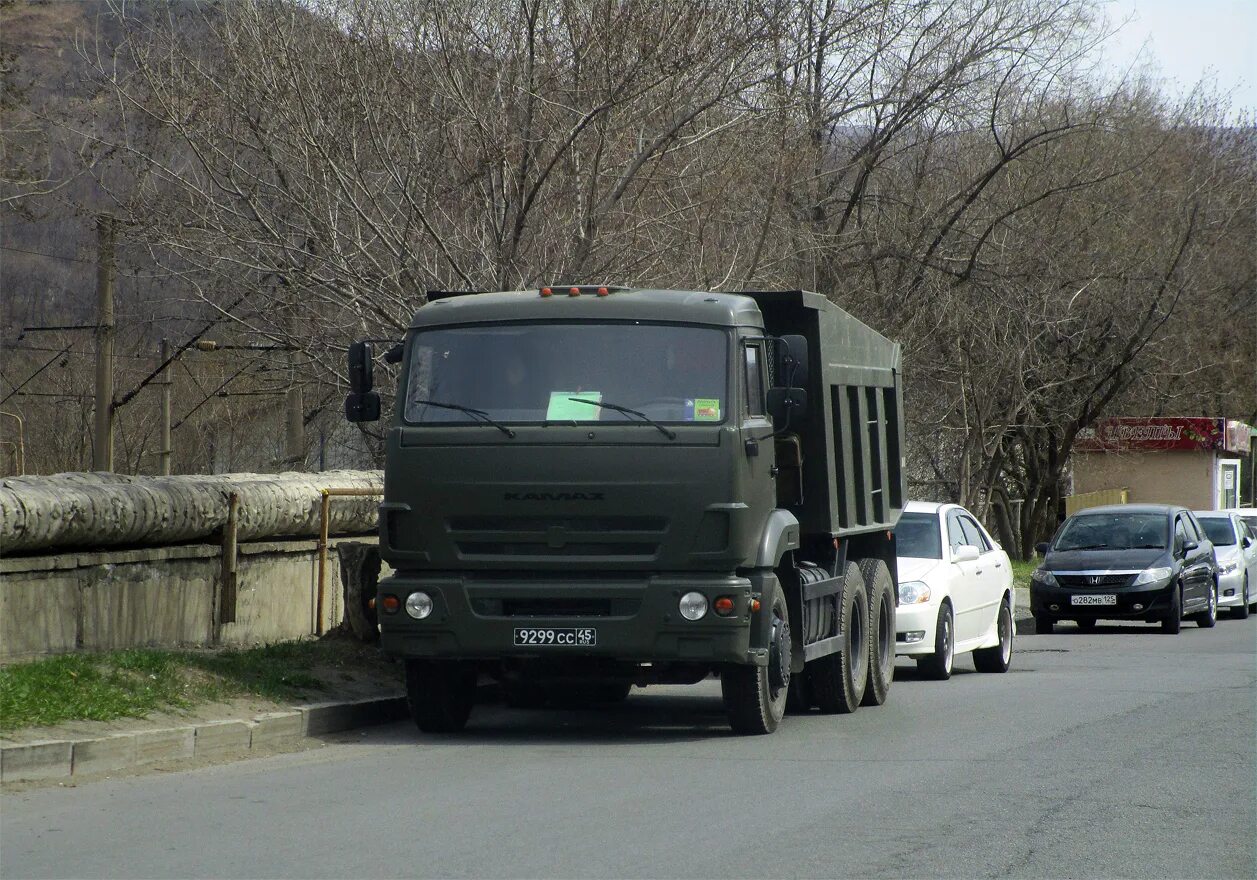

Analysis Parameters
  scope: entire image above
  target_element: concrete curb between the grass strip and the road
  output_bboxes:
[0,694,406,783]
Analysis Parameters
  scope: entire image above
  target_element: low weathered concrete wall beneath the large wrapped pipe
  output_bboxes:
[0,537,380,661]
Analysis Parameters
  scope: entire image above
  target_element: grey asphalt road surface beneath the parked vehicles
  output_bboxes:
[0,620,1257,880]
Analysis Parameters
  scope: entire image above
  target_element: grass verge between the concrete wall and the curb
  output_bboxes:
[0,640,378,732]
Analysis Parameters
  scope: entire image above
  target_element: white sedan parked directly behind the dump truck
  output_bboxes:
[895,502,1017,679]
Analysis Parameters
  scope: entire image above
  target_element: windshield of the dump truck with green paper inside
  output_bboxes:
[405,323,729,429]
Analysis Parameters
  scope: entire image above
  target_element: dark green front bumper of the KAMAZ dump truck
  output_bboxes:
[377,573,768,665]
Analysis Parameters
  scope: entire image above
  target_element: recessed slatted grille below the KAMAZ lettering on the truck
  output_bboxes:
[446,517,667,558]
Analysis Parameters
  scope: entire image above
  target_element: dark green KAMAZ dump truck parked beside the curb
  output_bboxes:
[346,287,904,734]
